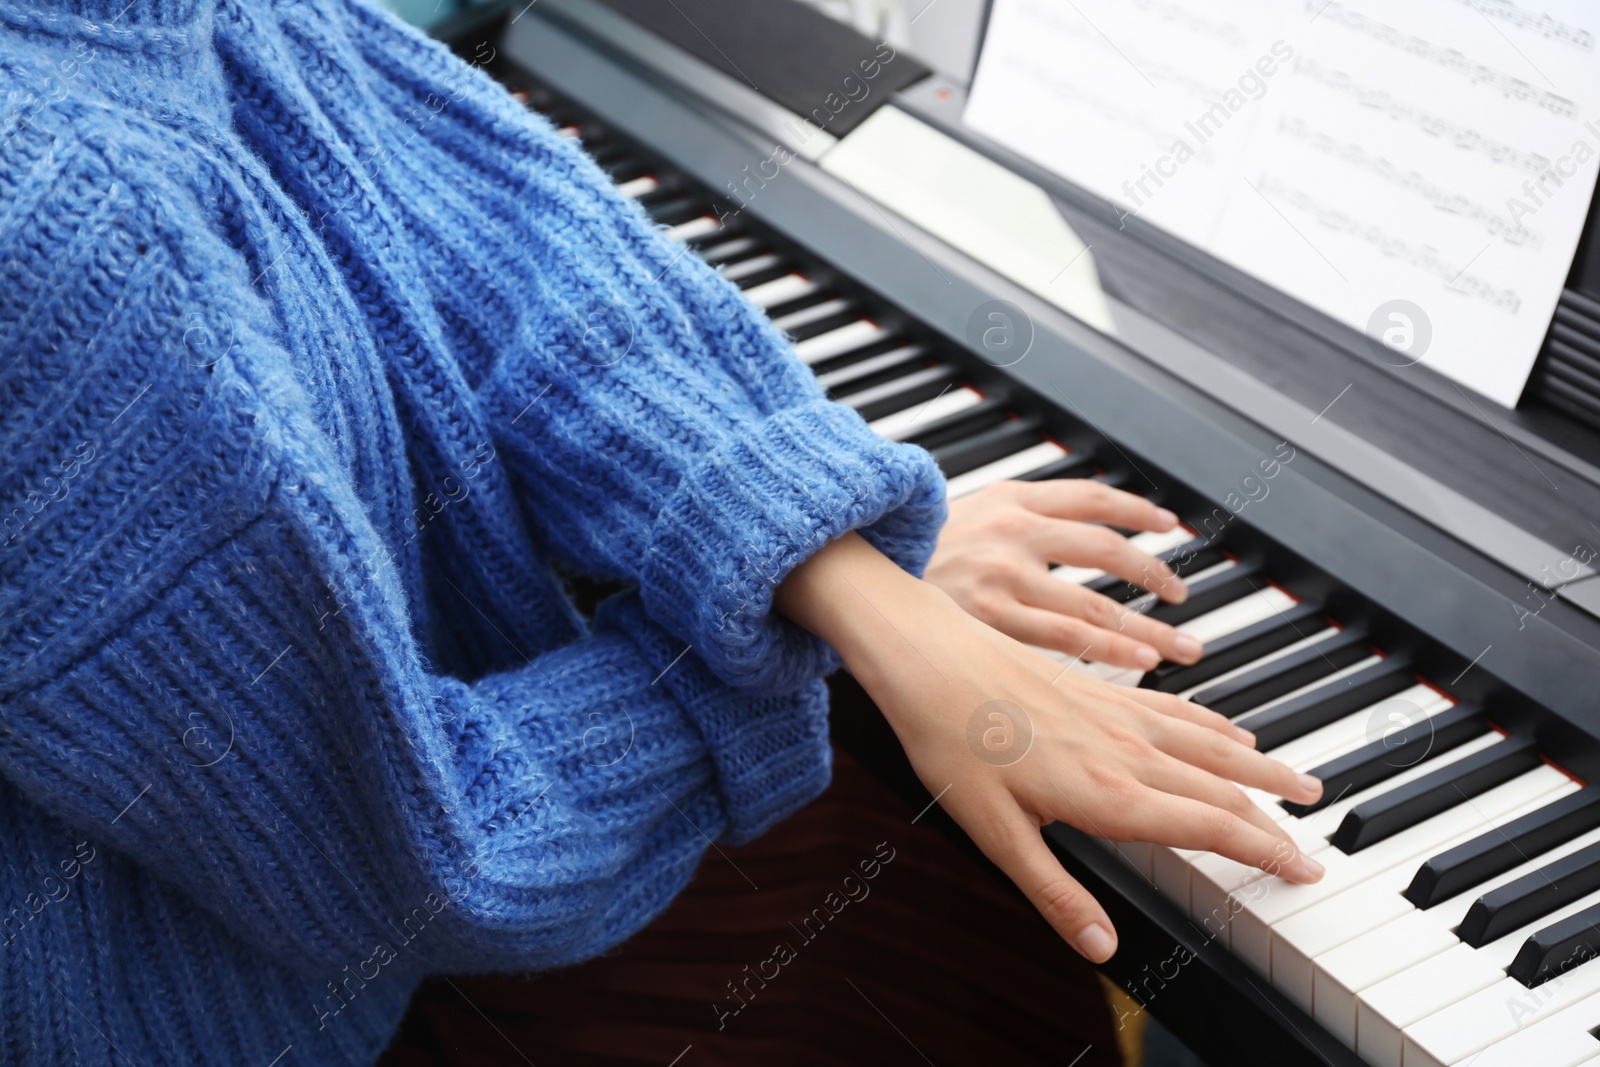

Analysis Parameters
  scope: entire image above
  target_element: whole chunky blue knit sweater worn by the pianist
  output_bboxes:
[0,0,944,1067]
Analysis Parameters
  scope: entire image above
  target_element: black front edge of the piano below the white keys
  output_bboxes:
[829,670,1363,1067]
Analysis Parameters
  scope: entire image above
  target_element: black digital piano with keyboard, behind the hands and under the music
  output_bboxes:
[435,0,1600,1067]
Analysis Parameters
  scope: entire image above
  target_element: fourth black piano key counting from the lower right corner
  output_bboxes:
[1328,737,1539,853]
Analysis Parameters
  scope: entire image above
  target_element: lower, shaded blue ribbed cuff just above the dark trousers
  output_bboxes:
[595,595,832,845]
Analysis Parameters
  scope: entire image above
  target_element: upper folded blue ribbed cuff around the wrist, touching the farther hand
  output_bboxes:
[640,402,946,691]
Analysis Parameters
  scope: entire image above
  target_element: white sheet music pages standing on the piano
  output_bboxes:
[966,0,1600,406]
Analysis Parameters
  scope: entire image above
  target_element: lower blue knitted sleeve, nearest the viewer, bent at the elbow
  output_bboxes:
[0,118,827,974]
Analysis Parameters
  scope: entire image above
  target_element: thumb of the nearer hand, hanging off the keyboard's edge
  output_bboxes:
[968,808,1117,963]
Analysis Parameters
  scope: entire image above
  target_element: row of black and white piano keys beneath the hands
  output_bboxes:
[508,79,1600,1067]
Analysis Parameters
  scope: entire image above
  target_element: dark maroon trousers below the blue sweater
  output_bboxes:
[379,710,1122,1067]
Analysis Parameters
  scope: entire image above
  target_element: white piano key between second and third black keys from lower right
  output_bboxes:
[1312,825,1600,1048]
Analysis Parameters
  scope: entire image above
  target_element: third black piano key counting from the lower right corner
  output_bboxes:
[1402,783,1600,909]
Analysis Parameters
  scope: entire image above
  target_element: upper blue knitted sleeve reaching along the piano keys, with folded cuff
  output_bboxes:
[283,0,944,689]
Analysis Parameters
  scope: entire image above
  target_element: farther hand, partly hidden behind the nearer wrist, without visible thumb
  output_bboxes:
[928,478,1203,670]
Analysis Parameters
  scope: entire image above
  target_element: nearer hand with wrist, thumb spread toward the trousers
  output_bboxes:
[776,534,1322,963]
